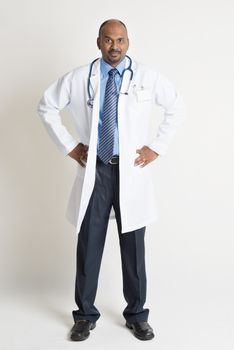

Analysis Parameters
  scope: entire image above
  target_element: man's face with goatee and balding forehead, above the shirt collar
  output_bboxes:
[97,22,129,67]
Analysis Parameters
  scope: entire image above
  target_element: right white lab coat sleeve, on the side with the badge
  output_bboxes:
[148,73,185,156]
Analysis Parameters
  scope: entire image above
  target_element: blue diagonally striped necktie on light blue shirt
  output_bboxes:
[98,68,118,164]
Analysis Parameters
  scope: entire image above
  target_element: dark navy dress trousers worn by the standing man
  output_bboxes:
[72,157,149,323]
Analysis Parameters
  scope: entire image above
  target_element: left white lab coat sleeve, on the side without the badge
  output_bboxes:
[37,72,78,156]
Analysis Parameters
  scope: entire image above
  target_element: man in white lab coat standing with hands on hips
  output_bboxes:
[38,19,183,341]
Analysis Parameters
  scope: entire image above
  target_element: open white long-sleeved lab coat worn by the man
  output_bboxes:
[38,59,183,235]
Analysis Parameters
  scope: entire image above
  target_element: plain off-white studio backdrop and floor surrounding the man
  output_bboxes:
[0,0,234,350]
